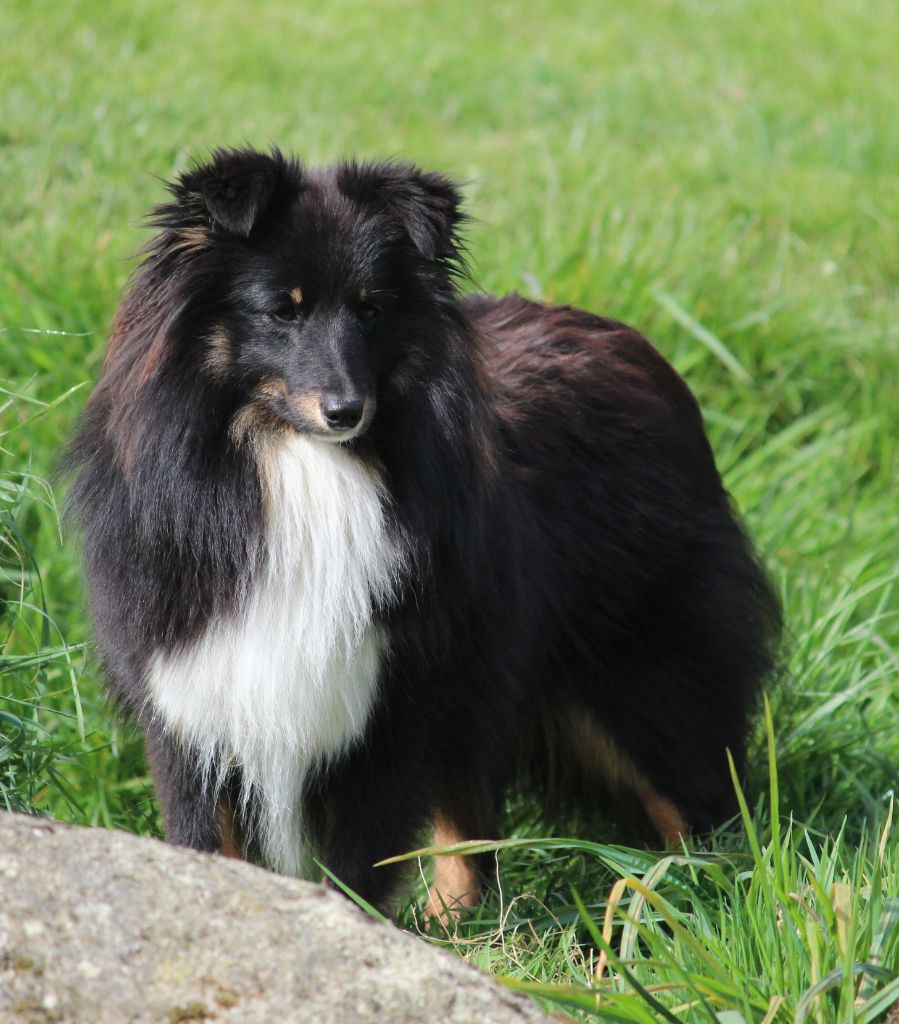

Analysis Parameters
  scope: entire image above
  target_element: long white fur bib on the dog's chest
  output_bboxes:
[147,435,402,872]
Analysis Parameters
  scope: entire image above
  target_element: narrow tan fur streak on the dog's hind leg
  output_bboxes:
[565,709,690,846]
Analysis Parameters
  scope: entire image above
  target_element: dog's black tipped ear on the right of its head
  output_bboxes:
[338,163,465,261]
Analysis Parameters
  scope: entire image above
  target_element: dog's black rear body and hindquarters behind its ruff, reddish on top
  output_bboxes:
[474,297,780,842]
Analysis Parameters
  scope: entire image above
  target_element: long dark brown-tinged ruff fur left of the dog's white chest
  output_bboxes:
[62,215,260,668]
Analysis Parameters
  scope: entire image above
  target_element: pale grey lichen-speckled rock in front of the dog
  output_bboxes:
[0,813,549,1024]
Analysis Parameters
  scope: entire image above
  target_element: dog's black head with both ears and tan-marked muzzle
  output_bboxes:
[157,151,460,441]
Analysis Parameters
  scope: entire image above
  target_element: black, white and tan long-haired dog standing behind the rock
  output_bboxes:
[68,150,780,908]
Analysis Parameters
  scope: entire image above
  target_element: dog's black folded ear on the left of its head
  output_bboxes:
[153,150,300,238]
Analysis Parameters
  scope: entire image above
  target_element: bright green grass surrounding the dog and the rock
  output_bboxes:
[0,0,899,1024]
